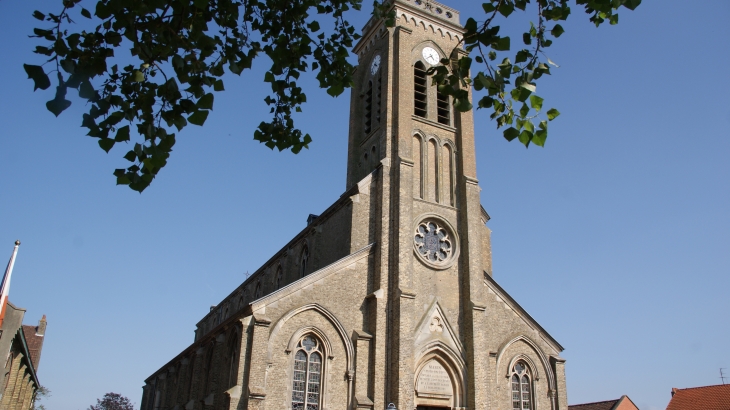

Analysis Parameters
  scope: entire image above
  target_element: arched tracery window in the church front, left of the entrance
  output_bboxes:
[291,335,324,410]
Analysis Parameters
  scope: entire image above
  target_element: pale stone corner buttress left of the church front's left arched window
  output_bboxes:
[248,314,271,410]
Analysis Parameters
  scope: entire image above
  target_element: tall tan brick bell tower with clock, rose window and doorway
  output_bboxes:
[347,0,491,410]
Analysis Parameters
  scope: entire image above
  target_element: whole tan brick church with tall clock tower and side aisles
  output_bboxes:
[141,0,568,410]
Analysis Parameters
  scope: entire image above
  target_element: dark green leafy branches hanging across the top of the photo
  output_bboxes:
[24,0,641,192]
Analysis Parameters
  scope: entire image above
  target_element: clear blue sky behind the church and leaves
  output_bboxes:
[0,0,730,410]
